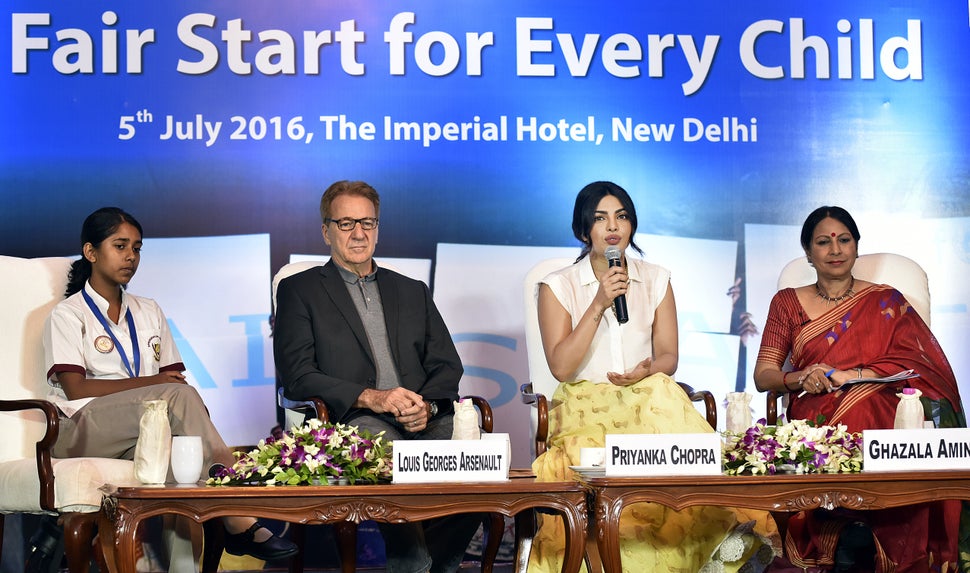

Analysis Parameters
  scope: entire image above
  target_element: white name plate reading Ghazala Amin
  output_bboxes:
[862,428,970,472]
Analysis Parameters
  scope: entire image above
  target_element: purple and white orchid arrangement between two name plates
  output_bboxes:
[722,419,863,475]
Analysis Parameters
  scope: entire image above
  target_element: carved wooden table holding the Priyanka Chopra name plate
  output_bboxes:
[582,471,970,573]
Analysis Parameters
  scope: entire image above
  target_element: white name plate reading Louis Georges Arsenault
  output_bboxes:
[391,440,509,483]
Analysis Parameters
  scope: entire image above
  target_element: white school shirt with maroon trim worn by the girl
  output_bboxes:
[44,283,185,416]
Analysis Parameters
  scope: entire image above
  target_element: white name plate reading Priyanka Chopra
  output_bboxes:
[606,432,721,477]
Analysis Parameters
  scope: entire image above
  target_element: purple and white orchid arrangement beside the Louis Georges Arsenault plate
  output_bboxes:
[206,419,391,485]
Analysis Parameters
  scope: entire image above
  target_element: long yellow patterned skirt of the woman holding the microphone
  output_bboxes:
[529,374,780,573]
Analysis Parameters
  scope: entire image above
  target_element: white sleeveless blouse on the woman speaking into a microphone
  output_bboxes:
[540,256,670,384]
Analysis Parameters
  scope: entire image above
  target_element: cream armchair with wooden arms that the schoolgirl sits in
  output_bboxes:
[0,256,138,573]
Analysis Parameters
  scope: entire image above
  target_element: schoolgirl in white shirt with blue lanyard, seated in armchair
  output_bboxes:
[44,207,298,560]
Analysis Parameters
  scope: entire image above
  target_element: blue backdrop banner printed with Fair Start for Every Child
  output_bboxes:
[0,0,970,456]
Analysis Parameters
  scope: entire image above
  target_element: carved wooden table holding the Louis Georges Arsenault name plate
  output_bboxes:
[98,470,587,573]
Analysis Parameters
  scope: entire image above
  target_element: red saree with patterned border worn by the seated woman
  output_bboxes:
[758,285,961,572]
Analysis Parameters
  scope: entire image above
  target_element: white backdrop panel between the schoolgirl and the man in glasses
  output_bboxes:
[130,234,276,445]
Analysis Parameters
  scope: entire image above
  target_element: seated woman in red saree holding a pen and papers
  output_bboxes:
[754,207,966,573]
